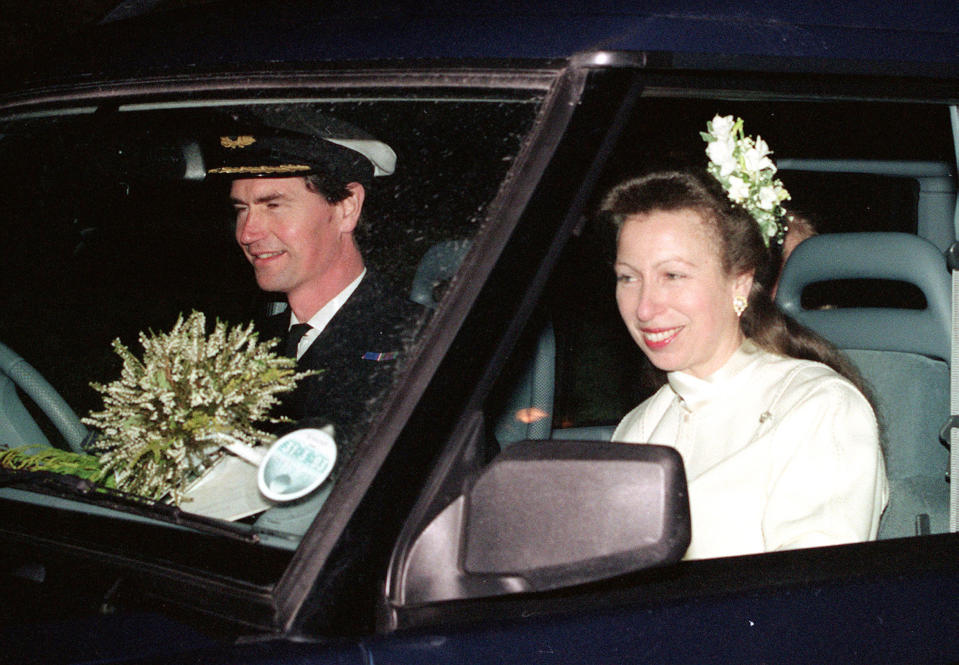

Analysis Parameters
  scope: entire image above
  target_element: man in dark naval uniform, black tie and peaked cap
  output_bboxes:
[208,115,417,453]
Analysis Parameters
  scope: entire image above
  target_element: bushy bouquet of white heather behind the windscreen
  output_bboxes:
[83,312,313,504]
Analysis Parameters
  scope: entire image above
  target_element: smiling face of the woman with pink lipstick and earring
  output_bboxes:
[615,210,752,378]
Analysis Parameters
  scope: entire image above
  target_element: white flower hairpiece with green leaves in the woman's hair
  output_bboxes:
[700,115,789,247]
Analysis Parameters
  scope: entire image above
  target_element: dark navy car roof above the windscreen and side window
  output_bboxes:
[11,0,959,87]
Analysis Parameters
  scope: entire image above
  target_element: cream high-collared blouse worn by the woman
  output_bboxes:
[613,340,889,559]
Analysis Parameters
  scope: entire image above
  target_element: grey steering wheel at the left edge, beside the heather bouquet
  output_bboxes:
[0,343,87,452]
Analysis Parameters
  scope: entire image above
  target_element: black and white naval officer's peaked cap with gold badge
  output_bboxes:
[207,112,396,184]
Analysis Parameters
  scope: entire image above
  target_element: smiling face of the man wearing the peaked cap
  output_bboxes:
[230,177,355,297]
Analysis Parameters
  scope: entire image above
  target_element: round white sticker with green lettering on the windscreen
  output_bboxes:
[257,429,336,501]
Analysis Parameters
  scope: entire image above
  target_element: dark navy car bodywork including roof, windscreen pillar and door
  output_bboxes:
[0,0,959,665]
